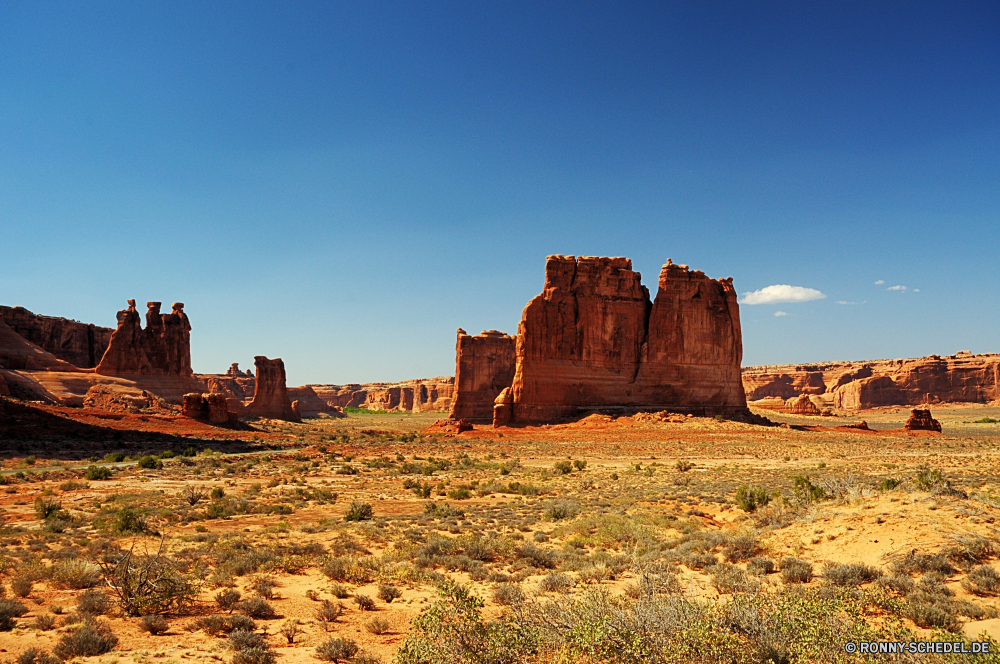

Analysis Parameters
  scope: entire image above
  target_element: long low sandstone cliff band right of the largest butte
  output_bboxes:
[743,351,1000,410]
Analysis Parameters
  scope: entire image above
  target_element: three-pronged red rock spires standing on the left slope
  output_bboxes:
[96,300,193,377]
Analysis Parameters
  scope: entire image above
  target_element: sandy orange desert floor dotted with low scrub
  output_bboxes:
[0,405,1000,664]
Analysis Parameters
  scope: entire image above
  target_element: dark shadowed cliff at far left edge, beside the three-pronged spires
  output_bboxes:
[0,306,114,369]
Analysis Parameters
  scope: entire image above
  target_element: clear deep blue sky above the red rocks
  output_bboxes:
[0,2,1000,384]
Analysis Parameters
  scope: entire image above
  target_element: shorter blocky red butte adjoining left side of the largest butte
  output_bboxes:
[450,328,516,422]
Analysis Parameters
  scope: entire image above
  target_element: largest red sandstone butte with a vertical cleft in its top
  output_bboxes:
[504,256,746,424]
